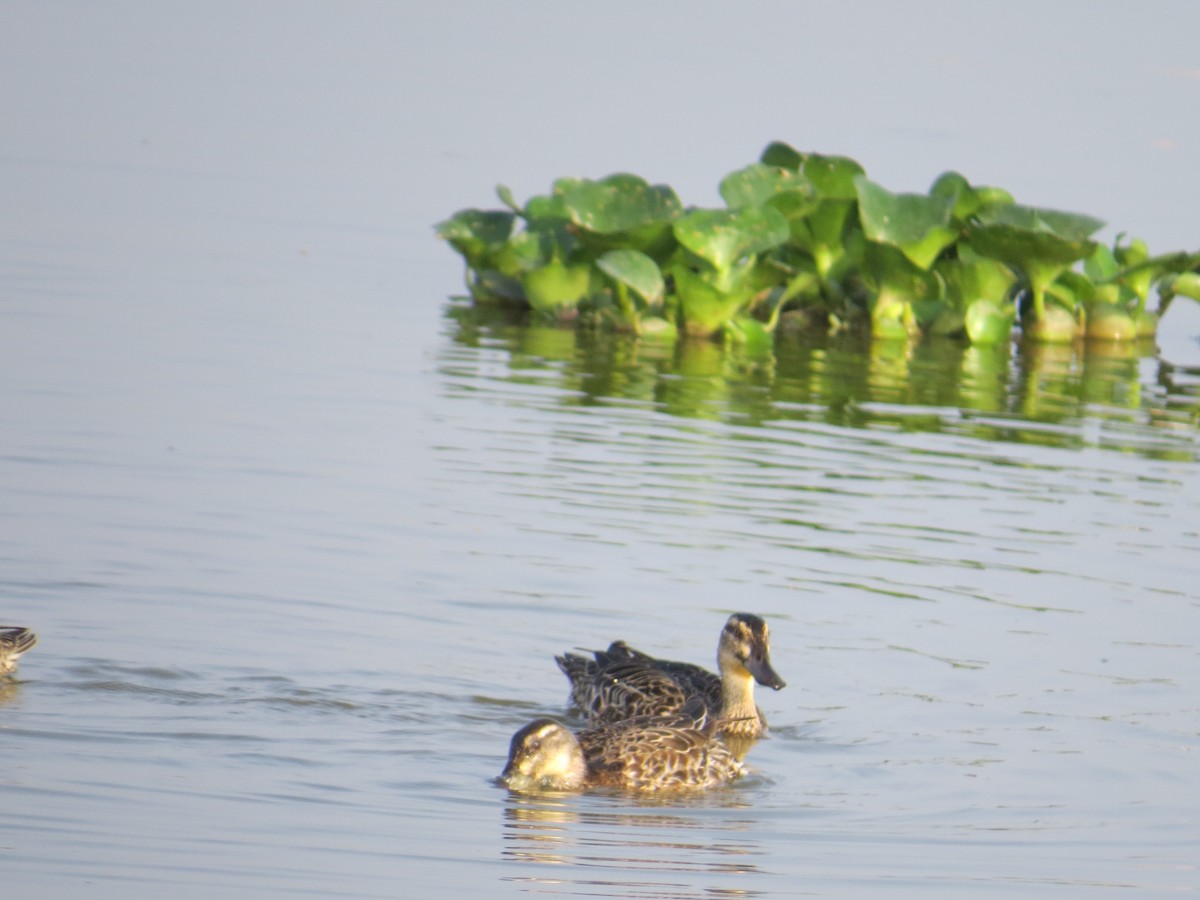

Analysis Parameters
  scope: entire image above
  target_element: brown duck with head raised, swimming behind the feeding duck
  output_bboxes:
[554,612,787,739]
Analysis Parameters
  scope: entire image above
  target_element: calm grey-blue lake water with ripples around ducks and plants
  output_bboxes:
[0,2,1200,898]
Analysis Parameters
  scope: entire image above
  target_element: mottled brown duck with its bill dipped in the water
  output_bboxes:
[498,701,745,793]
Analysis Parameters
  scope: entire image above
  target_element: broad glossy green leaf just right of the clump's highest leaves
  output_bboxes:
[854,175,958,269]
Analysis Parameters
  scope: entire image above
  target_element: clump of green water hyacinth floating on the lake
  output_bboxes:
[437,142,1200,344]
